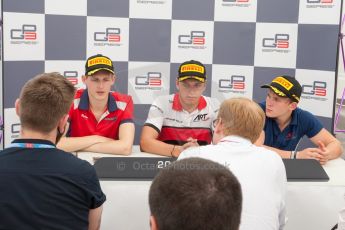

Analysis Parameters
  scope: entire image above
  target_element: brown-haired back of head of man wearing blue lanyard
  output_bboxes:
[18,72,75,133]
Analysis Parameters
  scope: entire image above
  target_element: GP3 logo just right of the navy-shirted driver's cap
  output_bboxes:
[301,81,327,101]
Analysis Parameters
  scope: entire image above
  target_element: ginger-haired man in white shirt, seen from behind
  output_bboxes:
[179,98,286,230]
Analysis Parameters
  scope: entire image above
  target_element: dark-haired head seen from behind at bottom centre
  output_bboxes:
[149,158,242,230]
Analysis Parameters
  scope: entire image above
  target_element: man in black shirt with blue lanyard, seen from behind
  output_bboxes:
[0,73,106,230]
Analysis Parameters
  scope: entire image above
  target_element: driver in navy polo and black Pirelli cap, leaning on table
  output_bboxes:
[260,76,343,164]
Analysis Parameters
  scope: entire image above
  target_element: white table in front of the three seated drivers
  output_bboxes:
[77,146,345,230]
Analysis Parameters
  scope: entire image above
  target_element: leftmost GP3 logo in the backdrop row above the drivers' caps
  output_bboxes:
[10,24,38,45]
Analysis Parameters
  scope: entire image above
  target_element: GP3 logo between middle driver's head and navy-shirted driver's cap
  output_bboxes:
[218,75,246,94]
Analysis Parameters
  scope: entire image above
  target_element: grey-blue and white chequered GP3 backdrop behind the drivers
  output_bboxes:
[3,0,341,145]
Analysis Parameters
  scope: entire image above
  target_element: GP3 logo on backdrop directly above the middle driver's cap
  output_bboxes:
[178,30,206,49]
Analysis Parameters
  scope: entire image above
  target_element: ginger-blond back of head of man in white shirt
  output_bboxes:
[218,97,265,143]
